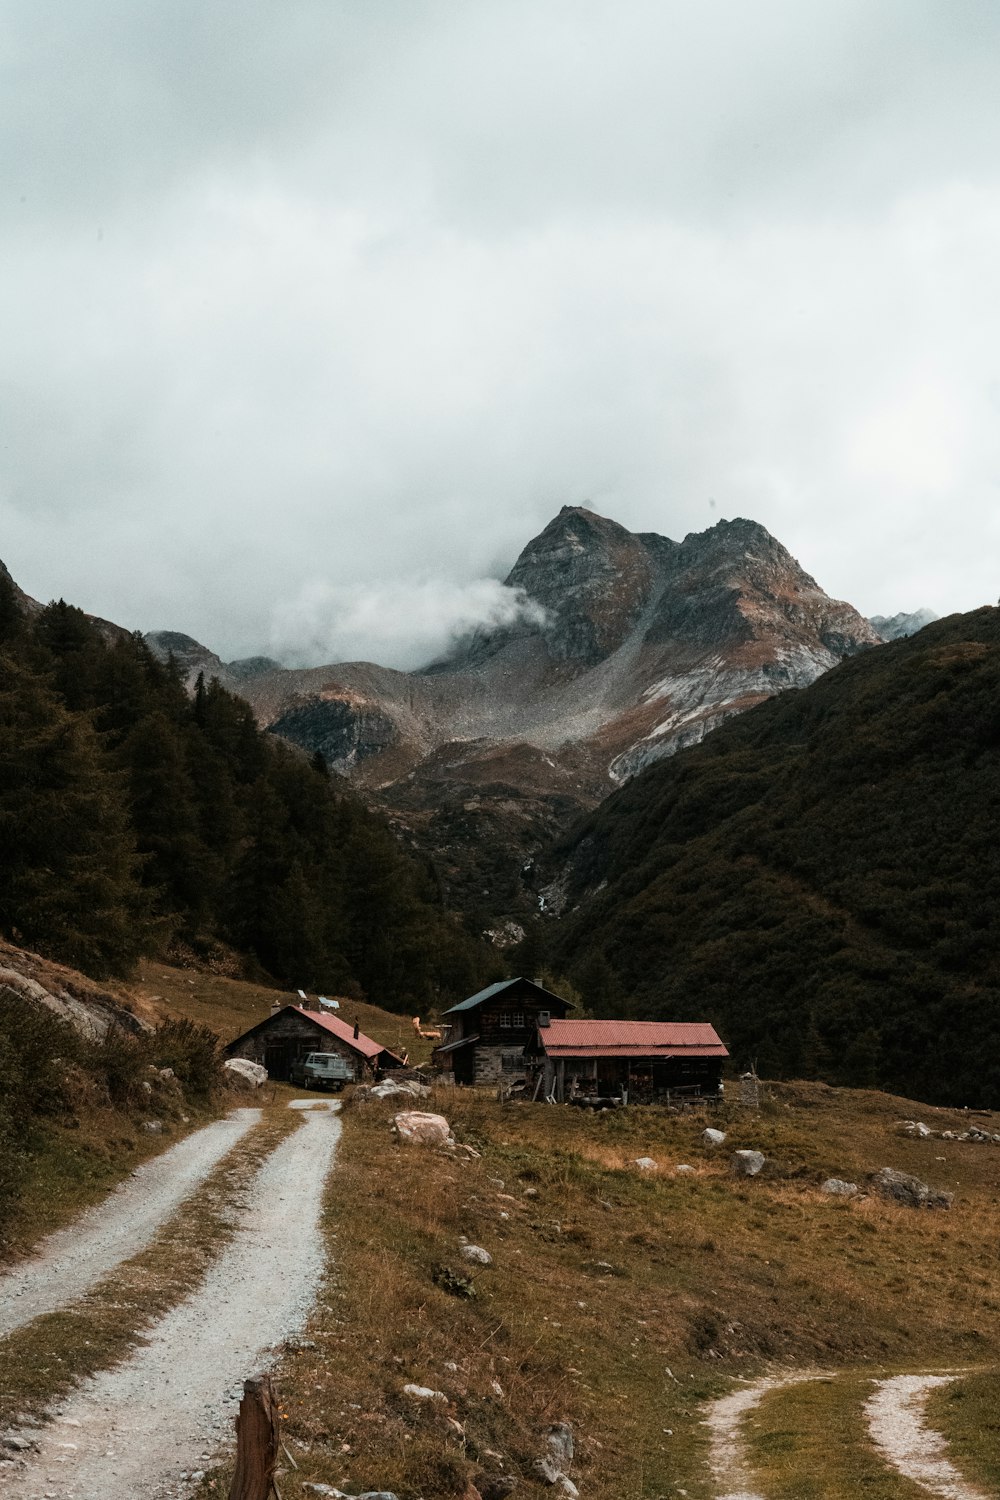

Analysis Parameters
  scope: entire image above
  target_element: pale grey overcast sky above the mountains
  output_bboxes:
[0,0,1000,665]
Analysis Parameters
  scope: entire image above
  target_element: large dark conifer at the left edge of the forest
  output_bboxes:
[0,657,148,977]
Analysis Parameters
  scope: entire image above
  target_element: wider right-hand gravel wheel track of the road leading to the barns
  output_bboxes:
[4,1104,340,1500]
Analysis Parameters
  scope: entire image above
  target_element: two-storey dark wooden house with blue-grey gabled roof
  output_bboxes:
[432,980,570,1083]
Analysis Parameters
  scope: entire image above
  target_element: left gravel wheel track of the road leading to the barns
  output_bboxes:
[0,1109,261,1338]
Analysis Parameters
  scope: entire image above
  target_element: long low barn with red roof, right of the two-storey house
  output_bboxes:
[525,1019,729,1104]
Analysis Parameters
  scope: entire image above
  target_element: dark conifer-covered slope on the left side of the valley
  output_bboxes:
[0,578,489,1010]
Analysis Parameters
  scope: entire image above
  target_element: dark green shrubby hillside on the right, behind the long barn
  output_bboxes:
[549,609,1000,1107]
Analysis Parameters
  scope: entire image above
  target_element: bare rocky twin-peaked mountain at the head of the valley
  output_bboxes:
[224,506,880,801]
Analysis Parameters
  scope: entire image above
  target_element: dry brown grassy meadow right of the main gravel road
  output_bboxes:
[191,1086,1000,1500]
